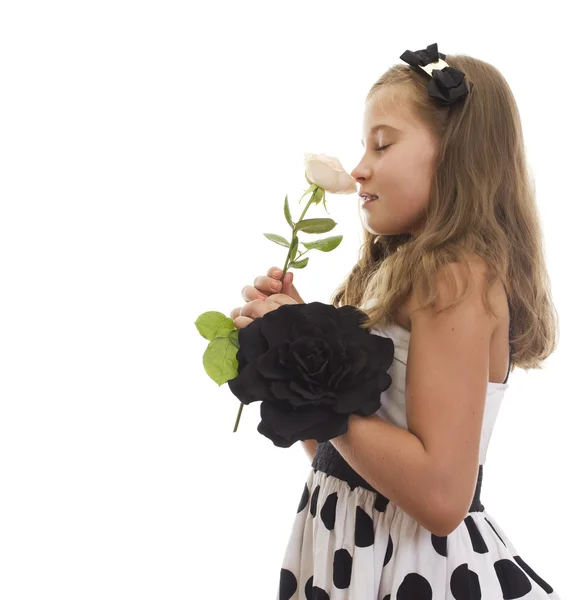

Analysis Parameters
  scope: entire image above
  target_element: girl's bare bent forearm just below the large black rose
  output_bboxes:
[330,414,449,535]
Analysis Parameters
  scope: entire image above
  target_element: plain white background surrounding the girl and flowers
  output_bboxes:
[0,0,583,600]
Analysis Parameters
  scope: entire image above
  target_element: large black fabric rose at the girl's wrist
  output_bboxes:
[227,302,395,448]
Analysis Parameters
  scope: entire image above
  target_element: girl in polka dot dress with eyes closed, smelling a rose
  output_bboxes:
[231,44,559,600]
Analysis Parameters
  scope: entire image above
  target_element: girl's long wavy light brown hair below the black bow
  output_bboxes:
[332,55,558,369]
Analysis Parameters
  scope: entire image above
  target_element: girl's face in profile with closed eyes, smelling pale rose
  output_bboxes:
[351,87,439,235]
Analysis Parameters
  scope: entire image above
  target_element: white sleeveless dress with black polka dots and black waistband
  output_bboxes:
[277,298,560,600]
